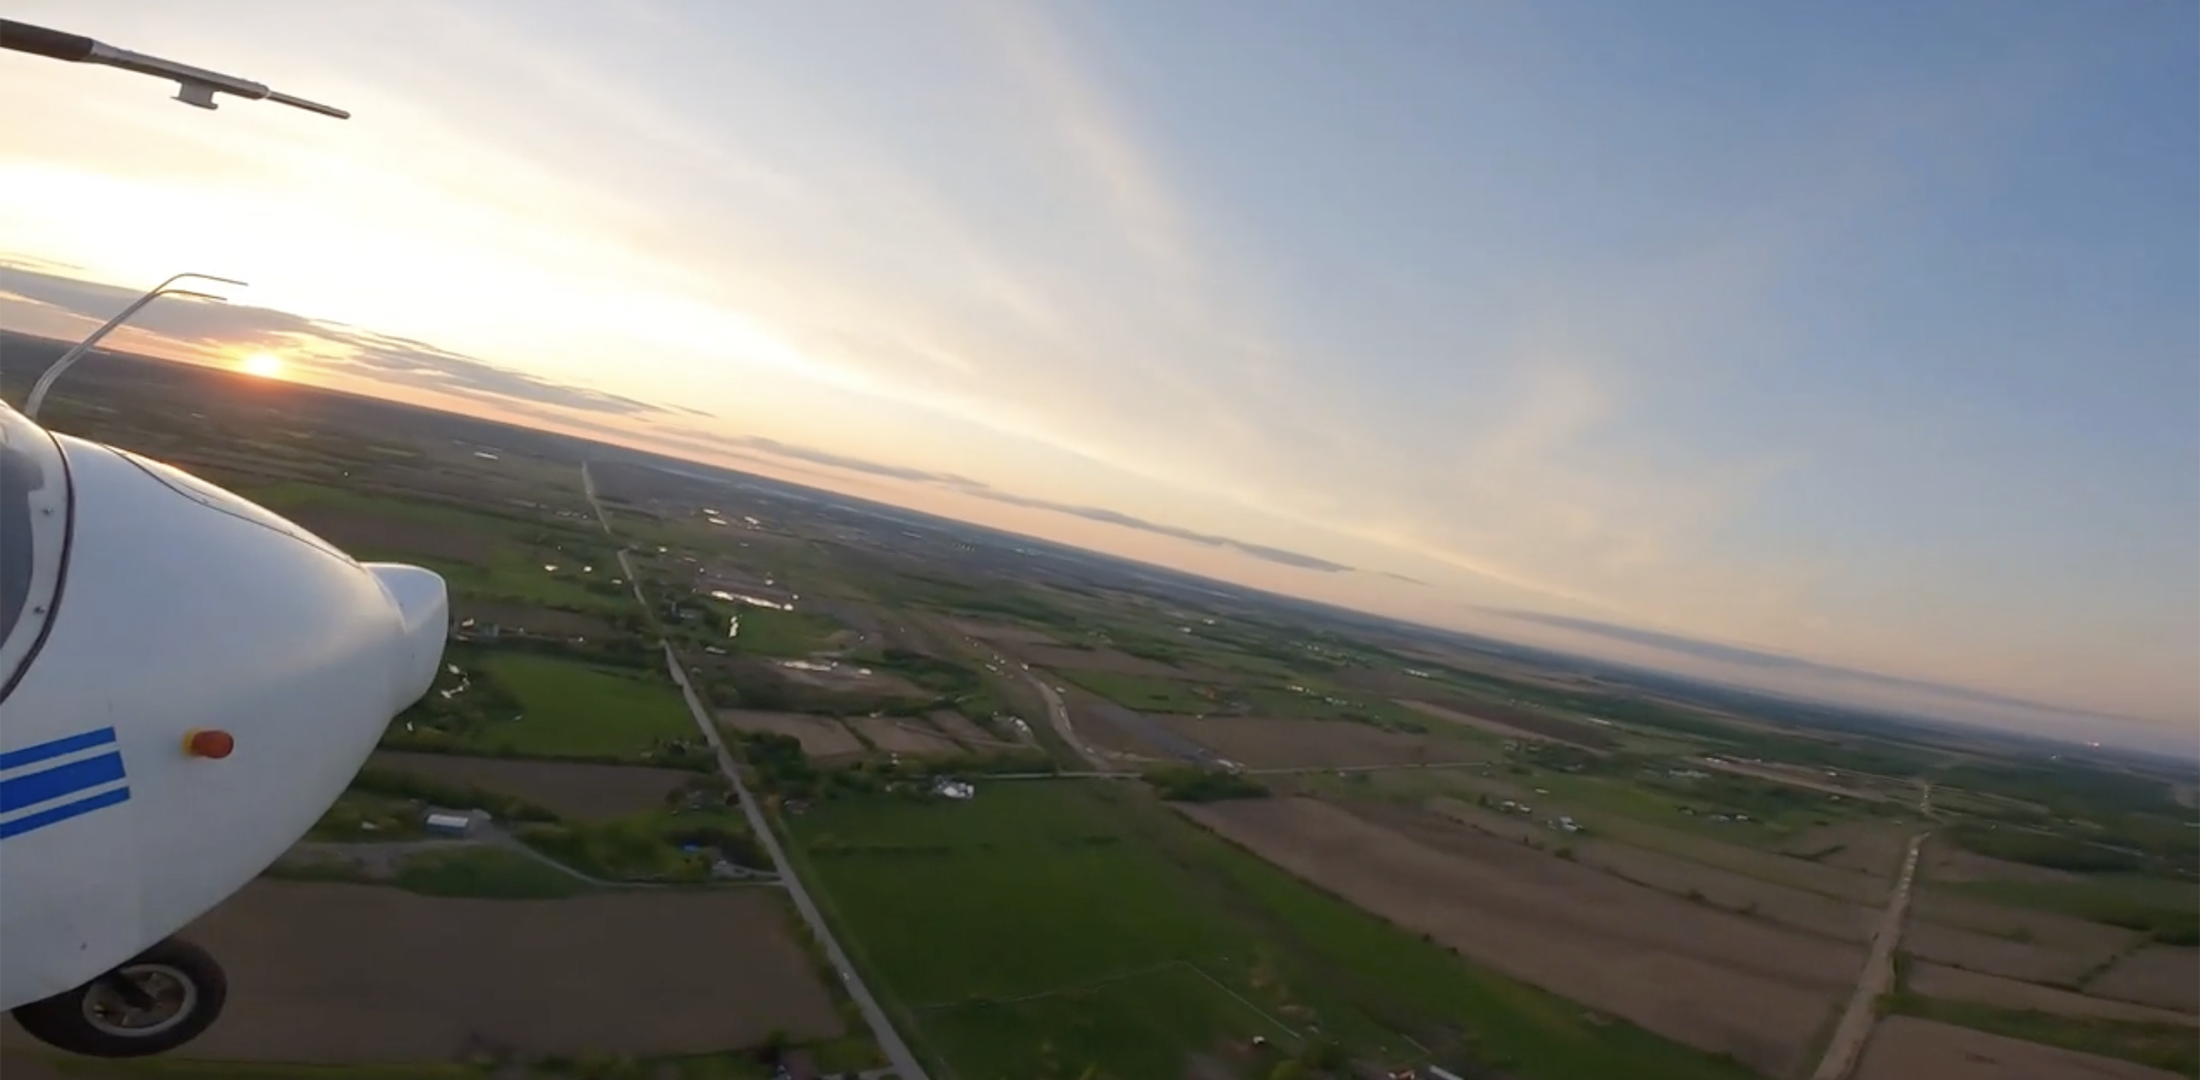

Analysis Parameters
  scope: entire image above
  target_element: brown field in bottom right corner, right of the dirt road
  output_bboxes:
[1857,1016,2178,1080]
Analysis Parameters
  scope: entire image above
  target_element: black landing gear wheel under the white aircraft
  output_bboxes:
[15,937,229,1058]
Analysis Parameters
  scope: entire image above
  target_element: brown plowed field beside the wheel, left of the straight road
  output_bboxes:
[4,880,845,1065]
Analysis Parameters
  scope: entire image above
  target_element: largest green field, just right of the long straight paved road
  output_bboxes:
[792,781,1749,1080]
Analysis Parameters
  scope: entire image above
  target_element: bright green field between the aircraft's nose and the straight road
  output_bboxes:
[460,653,695,759]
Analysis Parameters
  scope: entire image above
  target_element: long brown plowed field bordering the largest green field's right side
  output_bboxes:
[1179,798,1863,1076]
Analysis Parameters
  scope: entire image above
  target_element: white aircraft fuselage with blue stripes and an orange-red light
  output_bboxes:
[0,407,449,1010]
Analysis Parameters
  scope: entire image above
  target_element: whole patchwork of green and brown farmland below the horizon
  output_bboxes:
[17,349,2200,1080]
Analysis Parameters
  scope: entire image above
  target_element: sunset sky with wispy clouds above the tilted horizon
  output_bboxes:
[0,0,2200,746]
